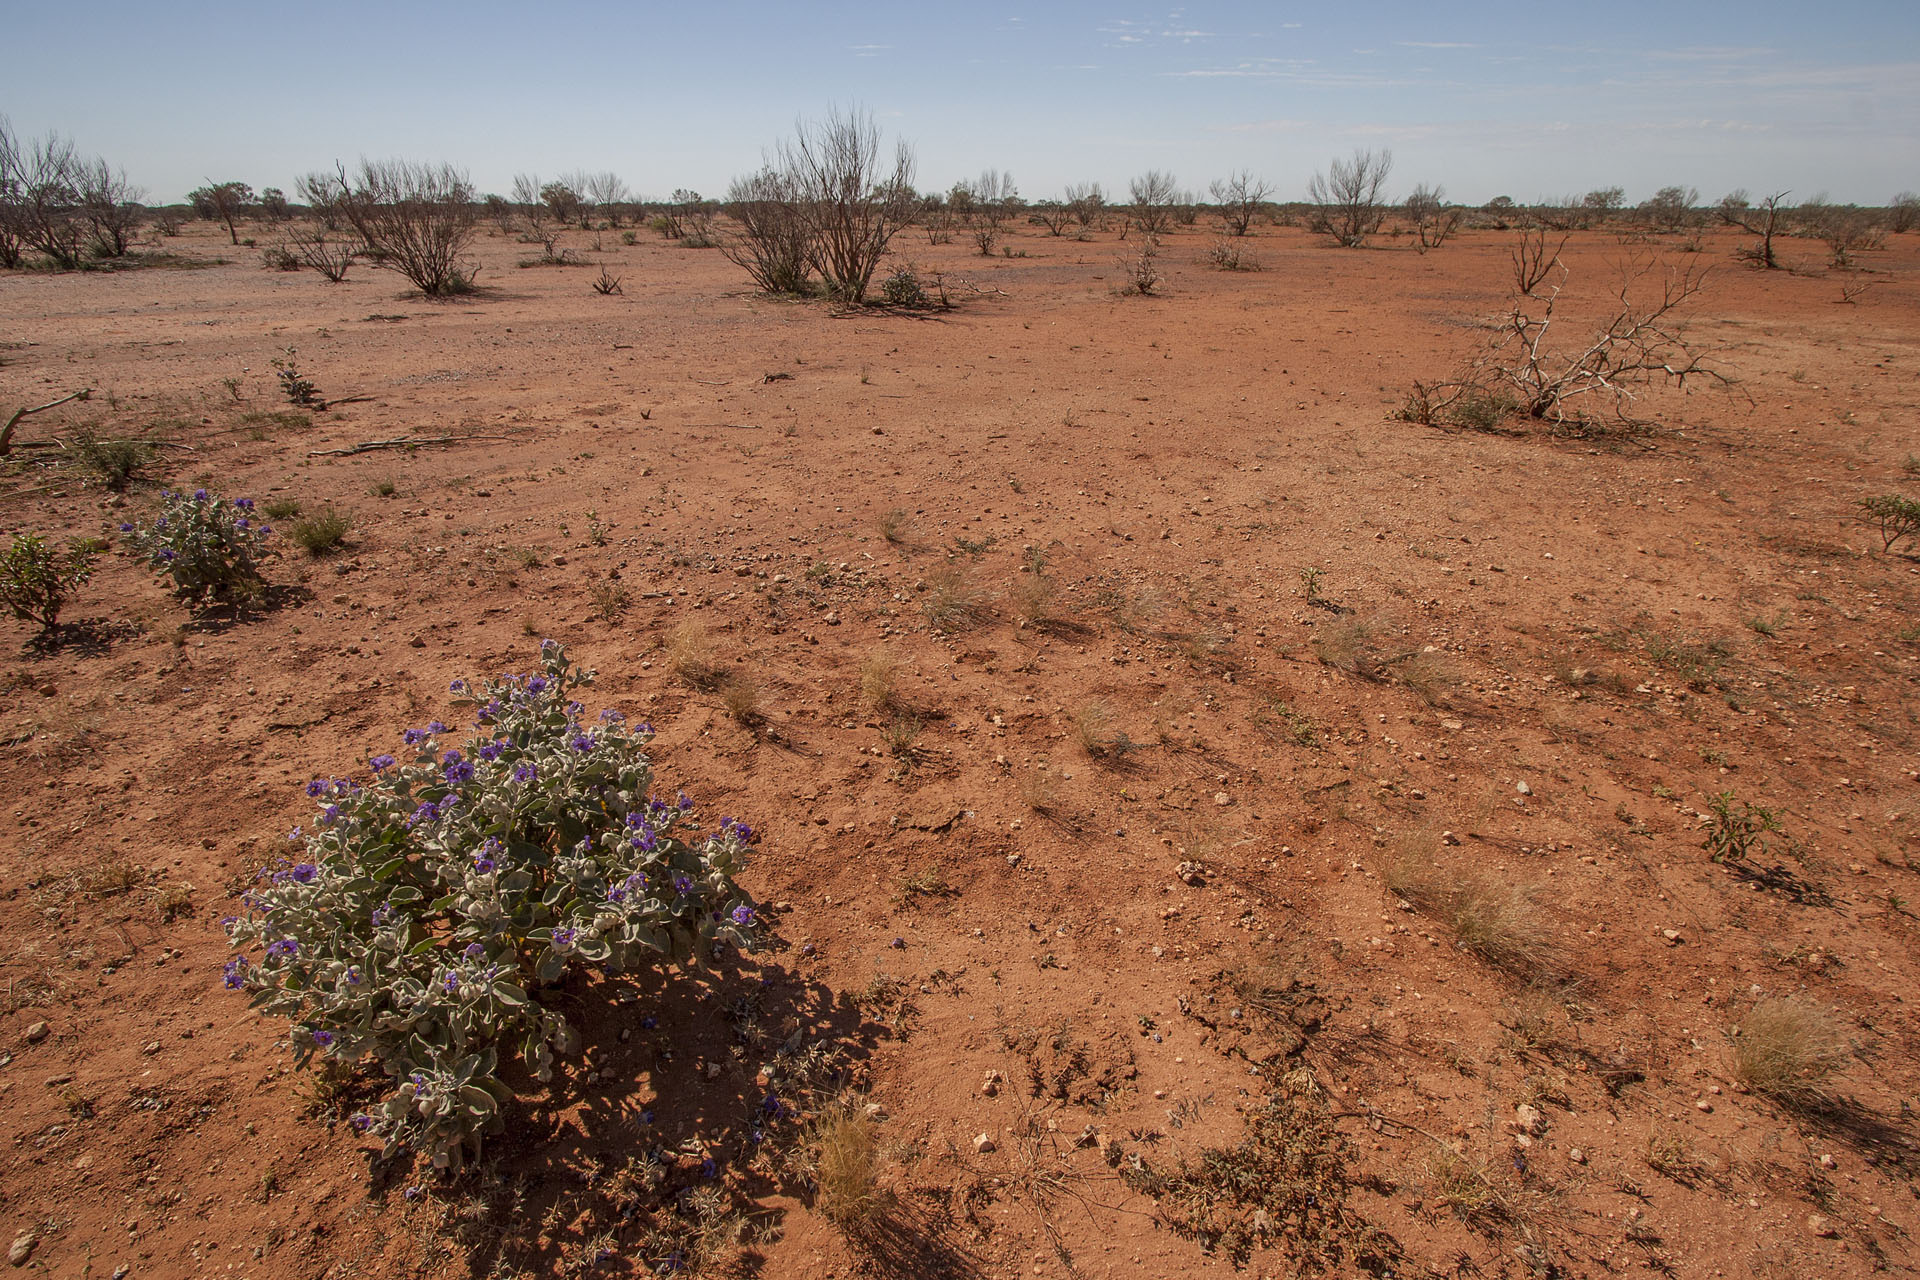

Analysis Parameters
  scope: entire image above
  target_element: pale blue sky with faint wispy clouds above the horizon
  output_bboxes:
[0,0,1920,203]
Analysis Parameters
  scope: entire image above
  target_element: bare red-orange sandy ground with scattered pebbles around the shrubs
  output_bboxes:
[0,214,1920,1280]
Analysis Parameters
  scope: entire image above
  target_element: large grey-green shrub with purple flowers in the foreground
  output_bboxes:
[227,641,760,1167]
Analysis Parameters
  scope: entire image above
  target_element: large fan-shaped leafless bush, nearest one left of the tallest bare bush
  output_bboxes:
[348,159,476,297]
